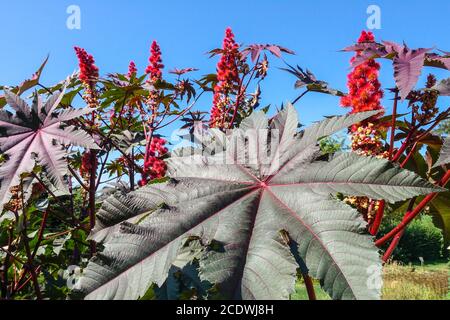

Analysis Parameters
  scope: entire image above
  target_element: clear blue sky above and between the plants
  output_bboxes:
[0,0,450,129]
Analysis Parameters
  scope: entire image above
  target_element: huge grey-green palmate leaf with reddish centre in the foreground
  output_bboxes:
[75,105,441,299]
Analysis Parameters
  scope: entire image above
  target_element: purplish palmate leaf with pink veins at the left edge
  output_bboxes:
[0,90,98,210]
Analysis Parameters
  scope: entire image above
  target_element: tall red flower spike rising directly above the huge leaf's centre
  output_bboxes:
[210,28,240,128]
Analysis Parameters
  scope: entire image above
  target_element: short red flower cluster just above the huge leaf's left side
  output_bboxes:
[139,137,168,186]
